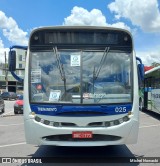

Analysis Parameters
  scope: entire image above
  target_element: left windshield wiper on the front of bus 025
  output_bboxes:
[53,47,66,94]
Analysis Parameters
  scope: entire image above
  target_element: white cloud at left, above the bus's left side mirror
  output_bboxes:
[0,11,28,45]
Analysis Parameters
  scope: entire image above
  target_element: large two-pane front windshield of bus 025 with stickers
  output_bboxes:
[30,47,132,104]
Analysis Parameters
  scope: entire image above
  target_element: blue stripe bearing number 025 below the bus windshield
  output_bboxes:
[30,104,132,116]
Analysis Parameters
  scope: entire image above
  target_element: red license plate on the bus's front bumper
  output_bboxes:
[72,131,93,139]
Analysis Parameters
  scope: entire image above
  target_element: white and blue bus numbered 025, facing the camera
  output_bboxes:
[9,26,142,146]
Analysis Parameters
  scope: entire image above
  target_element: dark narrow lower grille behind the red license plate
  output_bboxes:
[42,134,121,142]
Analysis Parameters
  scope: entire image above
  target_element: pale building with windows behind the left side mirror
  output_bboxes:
[0,49,26,93]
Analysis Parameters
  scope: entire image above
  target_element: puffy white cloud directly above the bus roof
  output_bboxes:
[63,6,131,31]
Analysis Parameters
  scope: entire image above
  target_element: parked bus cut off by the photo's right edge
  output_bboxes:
[144,66,160,114]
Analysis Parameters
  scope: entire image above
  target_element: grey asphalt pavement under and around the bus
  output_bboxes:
[0,101,160,166]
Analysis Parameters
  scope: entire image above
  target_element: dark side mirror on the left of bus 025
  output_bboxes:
[8,50,16,71]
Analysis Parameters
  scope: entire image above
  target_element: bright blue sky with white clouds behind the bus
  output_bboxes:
[0,0,160,66]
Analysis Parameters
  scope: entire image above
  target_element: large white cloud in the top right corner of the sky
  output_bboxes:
[108,0,160,32]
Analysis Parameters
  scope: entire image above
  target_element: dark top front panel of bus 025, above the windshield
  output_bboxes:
[29,26,133,52]
